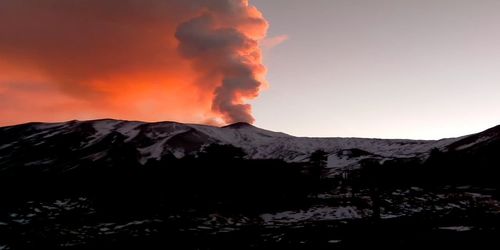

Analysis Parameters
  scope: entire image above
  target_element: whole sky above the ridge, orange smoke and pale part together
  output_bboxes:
[0,0,500,139]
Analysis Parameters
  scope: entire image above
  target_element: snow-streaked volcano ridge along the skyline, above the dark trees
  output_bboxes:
[0,119,474,173]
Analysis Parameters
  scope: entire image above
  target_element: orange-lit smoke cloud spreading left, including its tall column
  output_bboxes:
[0,0,268,123]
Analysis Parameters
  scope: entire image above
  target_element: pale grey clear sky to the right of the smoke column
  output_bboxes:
[251,0,500,139]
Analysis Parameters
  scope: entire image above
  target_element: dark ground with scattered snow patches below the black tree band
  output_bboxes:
[0,185,500,249]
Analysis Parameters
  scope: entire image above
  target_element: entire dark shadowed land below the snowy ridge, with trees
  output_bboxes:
[0,120,500,250]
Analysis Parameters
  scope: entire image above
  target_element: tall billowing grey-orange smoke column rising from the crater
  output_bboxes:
[175,0,268,123]
